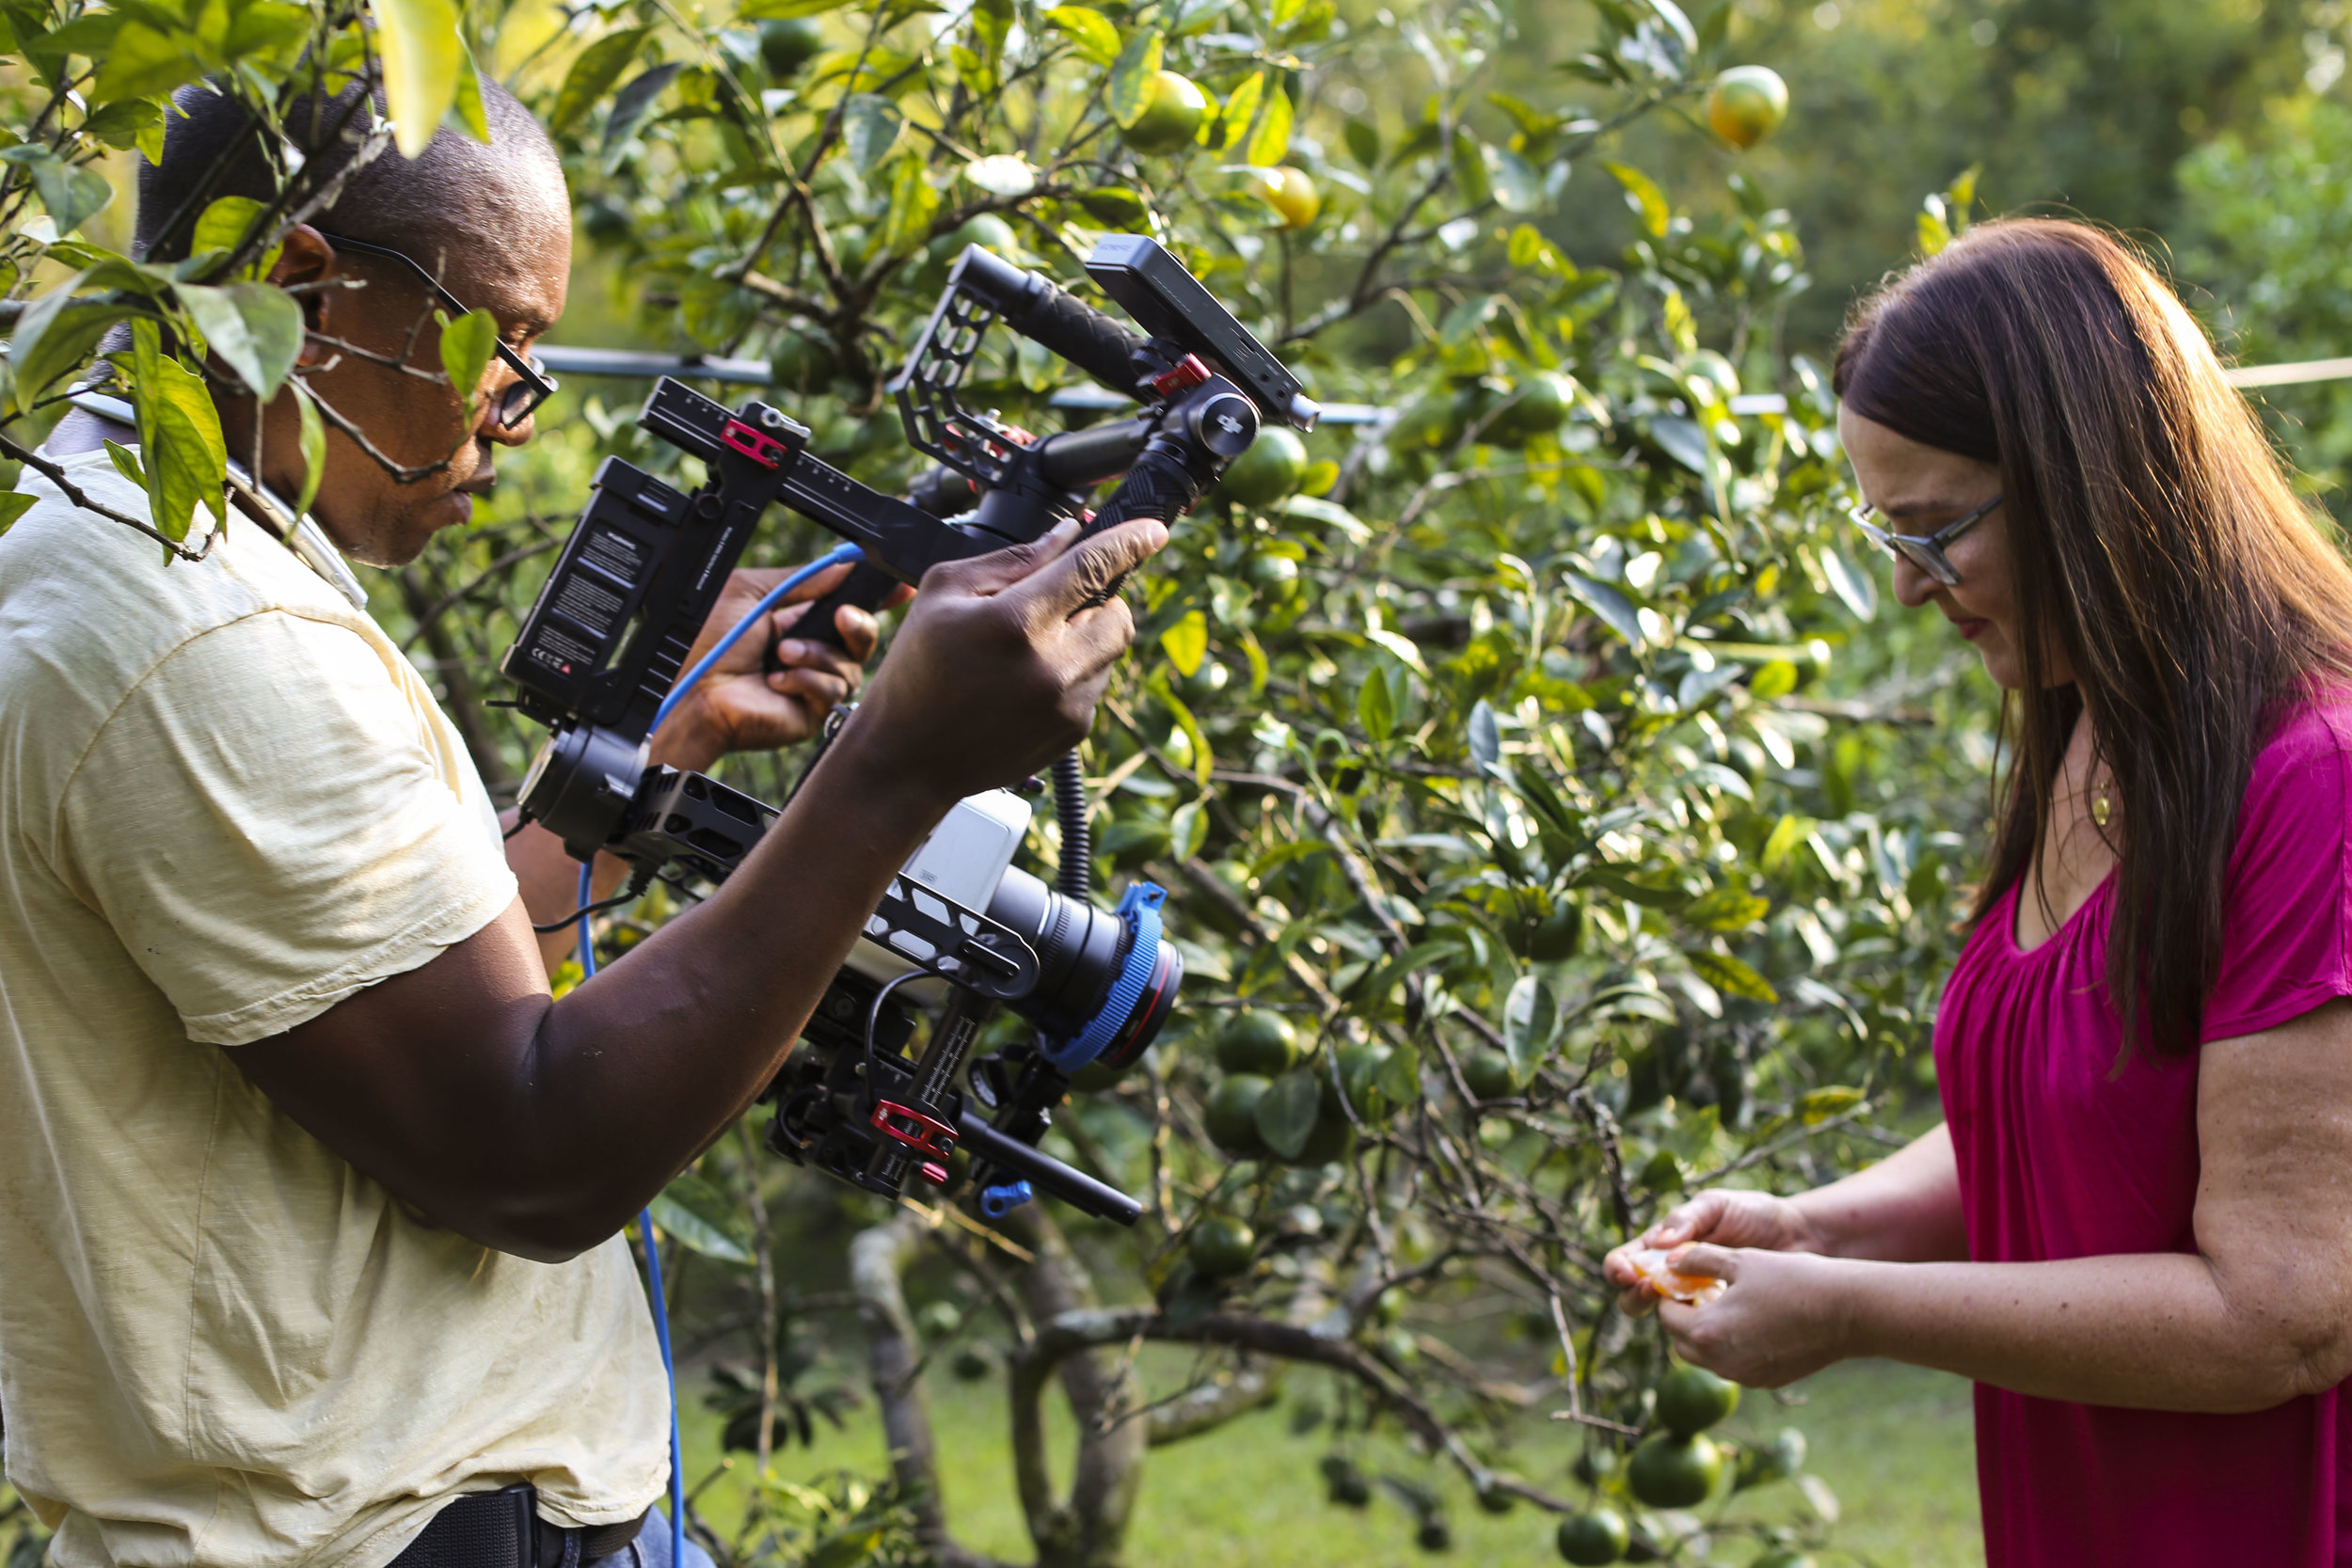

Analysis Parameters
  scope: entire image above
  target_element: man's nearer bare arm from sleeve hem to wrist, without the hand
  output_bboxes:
[255,734,953,1260]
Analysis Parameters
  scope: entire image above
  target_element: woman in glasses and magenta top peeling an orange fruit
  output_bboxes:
[1607,218,2352,1568]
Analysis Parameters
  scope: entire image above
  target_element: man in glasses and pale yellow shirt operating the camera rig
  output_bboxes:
[0,82,1165,1568]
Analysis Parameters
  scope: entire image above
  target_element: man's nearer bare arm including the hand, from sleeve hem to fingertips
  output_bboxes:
[230,522,1167,1260]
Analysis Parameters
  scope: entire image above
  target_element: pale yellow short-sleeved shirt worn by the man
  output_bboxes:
[0,453,668,1568]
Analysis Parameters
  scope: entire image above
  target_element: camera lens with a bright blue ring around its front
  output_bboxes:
[988,870,1184,1069]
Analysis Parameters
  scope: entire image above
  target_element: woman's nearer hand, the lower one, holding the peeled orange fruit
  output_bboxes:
[1659,1241,1872,1389]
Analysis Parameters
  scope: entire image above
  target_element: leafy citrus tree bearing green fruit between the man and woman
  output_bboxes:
[0,0,1993,1566]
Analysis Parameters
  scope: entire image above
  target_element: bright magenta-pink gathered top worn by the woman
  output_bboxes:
[1936,693,2352,1568]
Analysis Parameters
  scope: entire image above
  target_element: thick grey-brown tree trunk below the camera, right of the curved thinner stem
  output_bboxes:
[1000,1204,1151,1568]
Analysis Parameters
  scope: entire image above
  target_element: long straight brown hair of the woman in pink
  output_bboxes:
[1835,218,2352,1053]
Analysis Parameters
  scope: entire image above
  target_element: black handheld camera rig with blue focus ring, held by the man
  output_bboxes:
[501,235,1317,1225]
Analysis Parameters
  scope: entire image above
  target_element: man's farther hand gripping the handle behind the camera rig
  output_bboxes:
[652,566,913,771]
